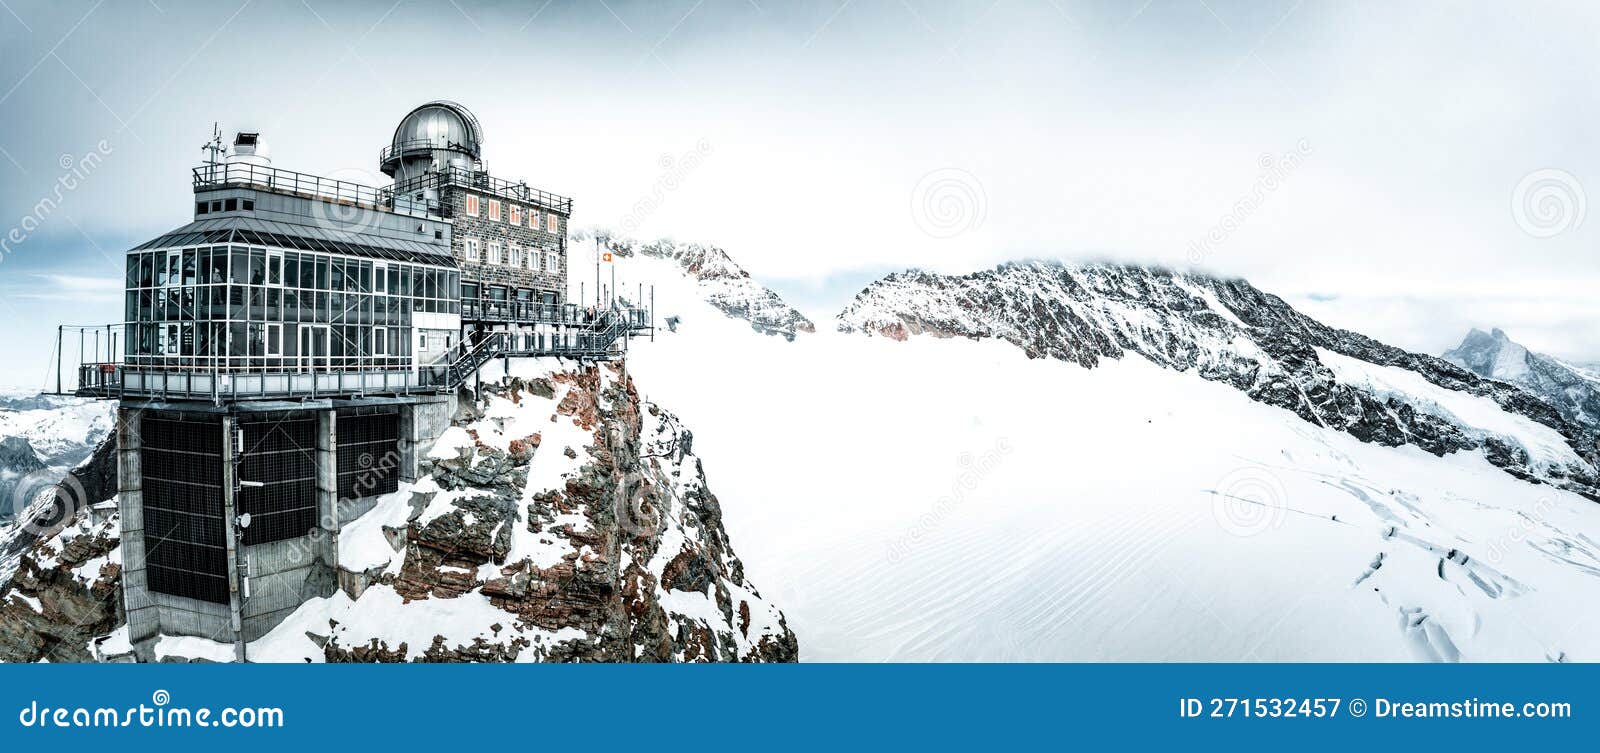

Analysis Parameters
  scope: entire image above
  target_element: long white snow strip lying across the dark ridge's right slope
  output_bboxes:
[1317,349,1582,467]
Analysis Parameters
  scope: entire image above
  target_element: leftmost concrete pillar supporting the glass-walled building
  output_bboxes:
[117,408,162,662]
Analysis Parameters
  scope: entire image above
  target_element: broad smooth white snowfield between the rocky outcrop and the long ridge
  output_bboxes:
[618,257,1600,660]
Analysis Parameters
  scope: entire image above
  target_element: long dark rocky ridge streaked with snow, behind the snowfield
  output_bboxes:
[838,262,1600,500]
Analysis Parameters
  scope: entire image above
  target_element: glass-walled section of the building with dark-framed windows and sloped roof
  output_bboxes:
[125,221,461,374]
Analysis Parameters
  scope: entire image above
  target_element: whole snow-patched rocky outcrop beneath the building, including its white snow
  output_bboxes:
[248,360,798,662]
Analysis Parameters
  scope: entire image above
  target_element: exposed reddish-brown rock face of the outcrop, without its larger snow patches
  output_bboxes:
[323,366,798,662]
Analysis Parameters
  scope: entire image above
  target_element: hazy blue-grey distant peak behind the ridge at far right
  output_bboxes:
[1443,329,1600,430]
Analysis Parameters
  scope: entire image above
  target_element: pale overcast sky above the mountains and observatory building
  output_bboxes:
[0,0,1600,387]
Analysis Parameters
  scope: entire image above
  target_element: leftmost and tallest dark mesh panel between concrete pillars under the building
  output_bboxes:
[139,416,227,604]
